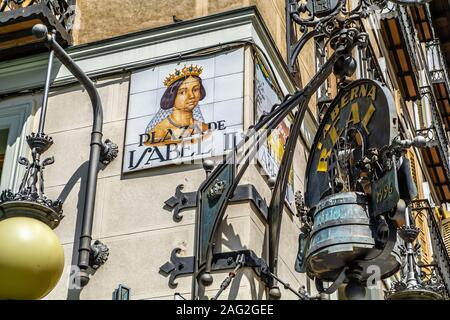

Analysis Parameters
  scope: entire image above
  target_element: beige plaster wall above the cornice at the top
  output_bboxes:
[73,0,286,56]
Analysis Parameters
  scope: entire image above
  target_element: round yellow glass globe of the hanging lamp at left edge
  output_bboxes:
[0,217,64,300]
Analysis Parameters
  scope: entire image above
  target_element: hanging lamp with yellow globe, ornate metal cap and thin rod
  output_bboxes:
[0,30,64,299]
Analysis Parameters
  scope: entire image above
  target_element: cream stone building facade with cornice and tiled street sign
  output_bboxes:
[0,0,450,300]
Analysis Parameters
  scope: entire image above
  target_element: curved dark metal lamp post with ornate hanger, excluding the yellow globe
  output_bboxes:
[0,24,118,298]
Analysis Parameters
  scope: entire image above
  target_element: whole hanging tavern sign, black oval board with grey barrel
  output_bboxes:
[297,79,400,294]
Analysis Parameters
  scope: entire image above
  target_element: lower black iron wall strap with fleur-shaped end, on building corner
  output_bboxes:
[159,248,269,287]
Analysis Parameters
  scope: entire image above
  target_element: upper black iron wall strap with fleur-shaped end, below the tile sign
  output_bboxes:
[164,184,268,222]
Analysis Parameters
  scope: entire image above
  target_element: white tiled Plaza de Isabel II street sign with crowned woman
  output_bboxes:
[124,48,246,172]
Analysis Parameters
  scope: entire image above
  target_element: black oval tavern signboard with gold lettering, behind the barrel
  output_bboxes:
[305,79,398,208]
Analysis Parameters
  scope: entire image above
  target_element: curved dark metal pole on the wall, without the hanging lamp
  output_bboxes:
[32,24,117,287]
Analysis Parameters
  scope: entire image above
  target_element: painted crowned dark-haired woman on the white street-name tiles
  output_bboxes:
[145,65,208,146]
